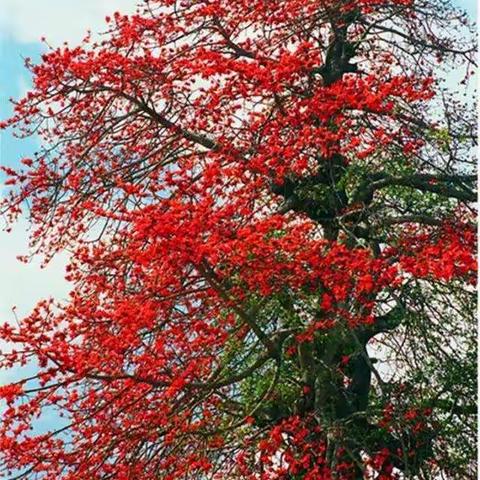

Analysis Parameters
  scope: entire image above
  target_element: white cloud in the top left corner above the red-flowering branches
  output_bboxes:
[0,0,138,46]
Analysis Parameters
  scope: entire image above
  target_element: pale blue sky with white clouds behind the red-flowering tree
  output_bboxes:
[0,0,477,436]
